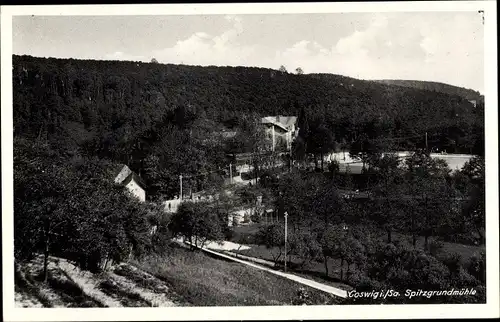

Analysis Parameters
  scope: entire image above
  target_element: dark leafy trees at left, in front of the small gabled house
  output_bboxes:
[14,139,156,276]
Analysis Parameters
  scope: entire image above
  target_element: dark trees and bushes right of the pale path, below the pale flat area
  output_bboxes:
[246,151,485,303]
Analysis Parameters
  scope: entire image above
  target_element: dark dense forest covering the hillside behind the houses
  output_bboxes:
[13,56,484,201]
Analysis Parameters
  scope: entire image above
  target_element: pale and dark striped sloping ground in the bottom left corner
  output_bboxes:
[15,256,189,308]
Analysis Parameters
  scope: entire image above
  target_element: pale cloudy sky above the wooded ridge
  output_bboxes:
[12,11,484,92]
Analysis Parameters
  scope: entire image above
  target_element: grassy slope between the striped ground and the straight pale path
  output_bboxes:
[134,246,342,306]
